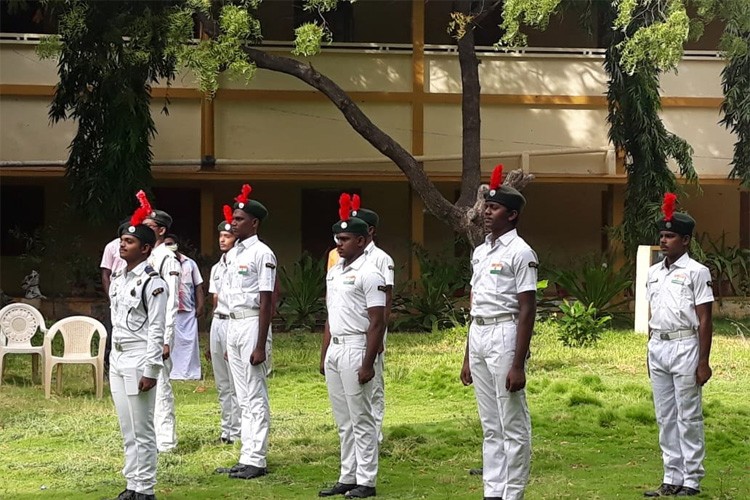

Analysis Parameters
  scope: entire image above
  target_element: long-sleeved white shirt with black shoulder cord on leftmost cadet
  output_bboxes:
[109,261,167,378]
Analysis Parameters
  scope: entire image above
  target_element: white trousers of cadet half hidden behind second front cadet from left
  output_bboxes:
[210,317,241,440]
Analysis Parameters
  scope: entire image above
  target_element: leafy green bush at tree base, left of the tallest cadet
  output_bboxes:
[393,246,471,332]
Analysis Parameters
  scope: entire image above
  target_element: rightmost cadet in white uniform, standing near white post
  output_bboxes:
[644,193,714,497]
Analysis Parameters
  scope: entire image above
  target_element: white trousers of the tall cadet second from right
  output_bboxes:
[469,321,531,500]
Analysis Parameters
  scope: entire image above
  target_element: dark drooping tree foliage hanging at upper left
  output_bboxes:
[42,0,176,221]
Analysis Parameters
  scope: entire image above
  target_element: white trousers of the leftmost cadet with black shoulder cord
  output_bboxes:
[109,342,156,495]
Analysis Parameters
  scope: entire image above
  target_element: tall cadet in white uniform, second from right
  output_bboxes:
[461,165,538,500]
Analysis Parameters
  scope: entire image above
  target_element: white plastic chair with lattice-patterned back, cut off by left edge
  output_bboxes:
[0,302,47,384]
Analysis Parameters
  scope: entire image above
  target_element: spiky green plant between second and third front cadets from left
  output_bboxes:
[279,253,326,330]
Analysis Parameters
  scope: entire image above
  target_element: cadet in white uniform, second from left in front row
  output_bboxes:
[217,184,276,479]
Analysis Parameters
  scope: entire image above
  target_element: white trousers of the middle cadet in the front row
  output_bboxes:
[325,335,378,487]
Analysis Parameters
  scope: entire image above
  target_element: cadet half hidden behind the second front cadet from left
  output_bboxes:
[207,217,241,444]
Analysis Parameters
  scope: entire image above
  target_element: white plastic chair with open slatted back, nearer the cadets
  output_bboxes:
[44,316,107,399]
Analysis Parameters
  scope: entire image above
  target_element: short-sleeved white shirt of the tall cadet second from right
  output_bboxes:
[471,229,539,318]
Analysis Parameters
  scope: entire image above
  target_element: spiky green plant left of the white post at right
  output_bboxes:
[550,259,633,313]
